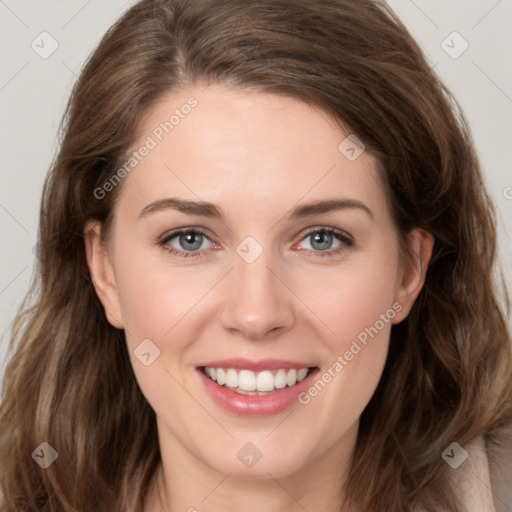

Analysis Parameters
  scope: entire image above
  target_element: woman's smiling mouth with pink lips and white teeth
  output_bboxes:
[196,359,319,416]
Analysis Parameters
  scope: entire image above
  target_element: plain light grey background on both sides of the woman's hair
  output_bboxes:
[0,0,512,374]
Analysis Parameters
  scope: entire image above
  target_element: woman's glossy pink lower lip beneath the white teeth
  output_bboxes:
[197,368,318,416]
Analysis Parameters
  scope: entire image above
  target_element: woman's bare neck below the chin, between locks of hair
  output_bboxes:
[145,424,357,512]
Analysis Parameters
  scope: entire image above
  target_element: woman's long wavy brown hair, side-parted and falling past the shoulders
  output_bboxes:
[0,0,512,512]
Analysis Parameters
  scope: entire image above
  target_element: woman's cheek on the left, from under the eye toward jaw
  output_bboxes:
[111,249,216,416]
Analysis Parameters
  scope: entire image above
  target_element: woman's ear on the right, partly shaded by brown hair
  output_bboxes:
[393,229,434,324]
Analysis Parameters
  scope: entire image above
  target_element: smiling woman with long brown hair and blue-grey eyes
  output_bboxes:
[0,0,512,512]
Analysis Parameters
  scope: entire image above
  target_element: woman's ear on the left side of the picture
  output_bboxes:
[84,221,124,329]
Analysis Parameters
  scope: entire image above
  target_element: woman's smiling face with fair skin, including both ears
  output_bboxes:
[86,85,431,478]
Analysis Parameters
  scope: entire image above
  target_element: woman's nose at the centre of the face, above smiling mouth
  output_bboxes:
[221,247,296,340]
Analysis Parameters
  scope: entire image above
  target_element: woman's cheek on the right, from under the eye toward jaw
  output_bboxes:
[288,244,402,424]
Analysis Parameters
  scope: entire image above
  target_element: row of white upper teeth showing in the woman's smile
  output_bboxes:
[204,366,308,391]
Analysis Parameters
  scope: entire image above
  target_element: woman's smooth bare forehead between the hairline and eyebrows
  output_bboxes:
[115,84,386,222]
